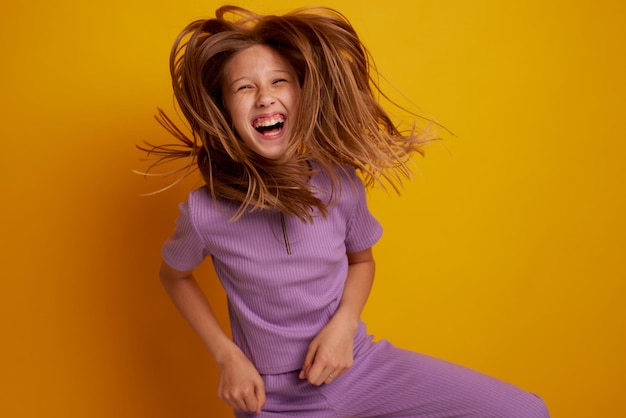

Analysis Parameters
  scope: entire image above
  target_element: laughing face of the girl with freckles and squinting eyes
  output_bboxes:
[222,45,300,159]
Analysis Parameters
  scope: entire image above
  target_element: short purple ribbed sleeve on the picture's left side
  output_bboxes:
[161,202,207,271]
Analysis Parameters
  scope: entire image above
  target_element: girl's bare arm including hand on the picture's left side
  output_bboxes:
[160,262,265,413]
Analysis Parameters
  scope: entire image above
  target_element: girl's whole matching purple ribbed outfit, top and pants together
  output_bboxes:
[163,168,548,418]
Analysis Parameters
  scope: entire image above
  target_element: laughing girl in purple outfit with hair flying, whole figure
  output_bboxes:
[144,6,548,418]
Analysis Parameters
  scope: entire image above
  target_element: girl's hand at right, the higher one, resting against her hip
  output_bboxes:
[299,316,356,386]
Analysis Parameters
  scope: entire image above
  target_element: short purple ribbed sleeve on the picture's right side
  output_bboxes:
[346,171,383,253]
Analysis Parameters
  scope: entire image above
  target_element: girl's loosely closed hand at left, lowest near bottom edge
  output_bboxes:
[217,350,265,414]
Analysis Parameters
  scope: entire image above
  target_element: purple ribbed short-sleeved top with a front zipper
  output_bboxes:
[163,164,382,374]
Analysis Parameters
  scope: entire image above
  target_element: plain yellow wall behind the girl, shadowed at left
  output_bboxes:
[0,0,626,418]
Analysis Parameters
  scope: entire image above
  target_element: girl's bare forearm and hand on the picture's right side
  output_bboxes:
[300,248,375,386]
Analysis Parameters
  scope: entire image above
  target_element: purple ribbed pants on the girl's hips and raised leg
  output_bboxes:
[235,341,549,418]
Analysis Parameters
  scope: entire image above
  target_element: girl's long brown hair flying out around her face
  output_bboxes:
[140,6,431,220]
